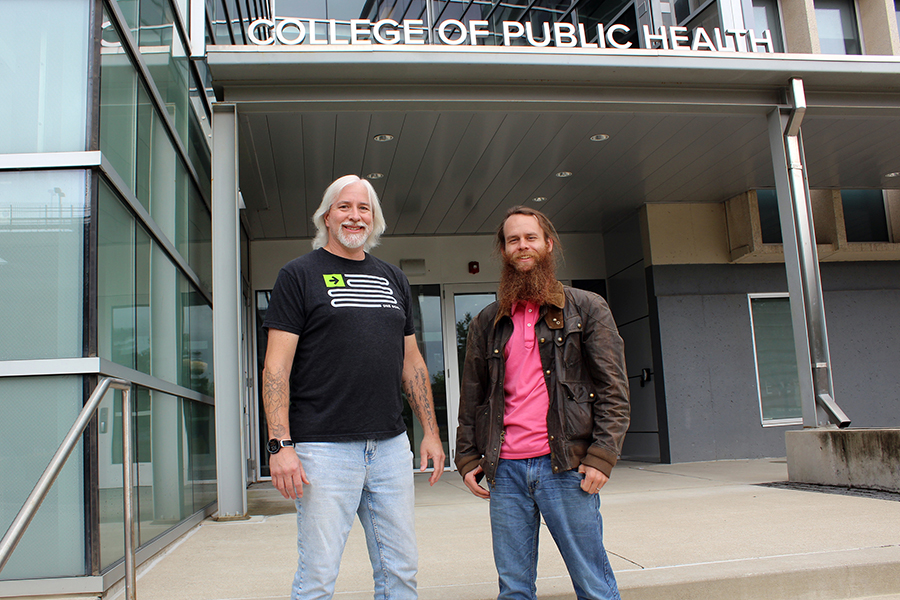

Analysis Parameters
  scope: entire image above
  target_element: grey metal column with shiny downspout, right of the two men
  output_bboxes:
[769,79,850,427]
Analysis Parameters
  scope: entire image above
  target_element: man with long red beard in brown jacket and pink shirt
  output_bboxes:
[456,206,630,600]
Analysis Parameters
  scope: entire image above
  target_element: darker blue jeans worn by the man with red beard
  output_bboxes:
[490,455,619,600]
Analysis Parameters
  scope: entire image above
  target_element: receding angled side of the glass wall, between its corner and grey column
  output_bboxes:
[96,0,216,570]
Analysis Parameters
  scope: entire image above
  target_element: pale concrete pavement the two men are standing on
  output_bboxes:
[137,459,900,600]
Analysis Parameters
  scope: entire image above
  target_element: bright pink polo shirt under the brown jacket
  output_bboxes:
[500,302,550,459]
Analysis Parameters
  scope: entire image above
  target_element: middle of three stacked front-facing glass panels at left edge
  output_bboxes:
[0,170,87,360]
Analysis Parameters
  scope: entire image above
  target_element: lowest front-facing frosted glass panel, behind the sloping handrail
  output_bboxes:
[0,376,85,580]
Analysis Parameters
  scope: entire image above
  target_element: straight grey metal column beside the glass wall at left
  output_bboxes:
[212,104,247,519]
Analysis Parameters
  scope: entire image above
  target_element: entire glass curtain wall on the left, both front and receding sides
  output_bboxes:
[0,0,216,580]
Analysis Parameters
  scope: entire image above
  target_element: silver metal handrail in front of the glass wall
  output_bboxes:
[0,377,135,600]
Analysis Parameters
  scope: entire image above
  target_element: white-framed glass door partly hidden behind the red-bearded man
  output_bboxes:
[444,283,497,463]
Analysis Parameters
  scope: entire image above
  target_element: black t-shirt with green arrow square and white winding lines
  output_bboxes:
[263,248,415,442]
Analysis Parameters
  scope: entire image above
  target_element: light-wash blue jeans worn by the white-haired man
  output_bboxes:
[291,433,419,600]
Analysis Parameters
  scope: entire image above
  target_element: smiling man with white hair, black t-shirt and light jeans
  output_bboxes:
[263,175,445,600]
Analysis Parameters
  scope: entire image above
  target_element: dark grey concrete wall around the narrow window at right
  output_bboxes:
[652,262,900,462]
